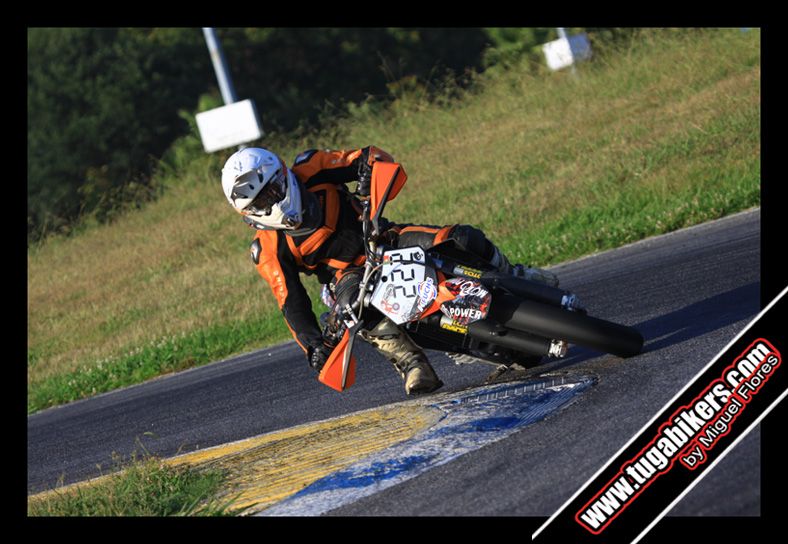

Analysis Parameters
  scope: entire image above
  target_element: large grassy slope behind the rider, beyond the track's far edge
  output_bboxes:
[27,29,761,412]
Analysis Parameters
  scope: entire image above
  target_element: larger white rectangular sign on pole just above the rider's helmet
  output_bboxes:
[195,99,263,153]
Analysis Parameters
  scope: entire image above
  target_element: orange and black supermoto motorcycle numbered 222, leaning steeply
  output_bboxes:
[318,162,643,391]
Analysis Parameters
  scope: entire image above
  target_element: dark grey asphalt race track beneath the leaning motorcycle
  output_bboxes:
[27,210,761,516]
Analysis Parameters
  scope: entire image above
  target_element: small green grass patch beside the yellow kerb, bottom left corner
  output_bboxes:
[27,456,234,517]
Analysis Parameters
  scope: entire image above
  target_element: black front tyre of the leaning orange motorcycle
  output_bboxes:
[489,293,643,357]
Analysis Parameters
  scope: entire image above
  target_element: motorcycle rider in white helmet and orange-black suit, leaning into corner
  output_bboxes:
[222,145,558,395]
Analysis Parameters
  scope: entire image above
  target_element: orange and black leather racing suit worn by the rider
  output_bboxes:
[251,146,502,364]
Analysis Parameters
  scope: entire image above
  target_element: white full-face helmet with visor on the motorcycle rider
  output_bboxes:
[222,147,303,230]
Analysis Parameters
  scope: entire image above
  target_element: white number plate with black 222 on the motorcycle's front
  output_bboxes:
[371,246,438,325]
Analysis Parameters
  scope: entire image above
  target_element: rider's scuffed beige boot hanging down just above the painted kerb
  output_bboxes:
[361,317,443,395]
